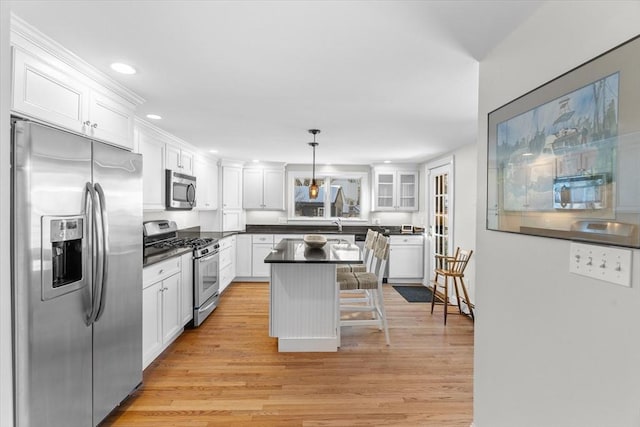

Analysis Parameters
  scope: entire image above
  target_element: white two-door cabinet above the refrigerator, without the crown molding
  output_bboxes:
[11,45,136,150]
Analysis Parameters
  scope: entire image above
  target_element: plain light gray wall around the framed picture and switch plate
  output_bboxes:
[474,1,640,427]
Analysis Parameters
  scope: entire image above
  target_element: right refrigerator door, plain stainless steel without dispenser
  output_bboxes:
[93,141,142,425]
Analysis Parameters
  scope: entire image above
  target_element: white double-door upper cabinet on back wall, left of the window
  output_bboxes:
[242,169,284,210]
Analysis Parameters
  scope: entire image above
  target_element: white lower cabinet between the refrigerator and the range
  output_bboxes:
[142,257,183,368]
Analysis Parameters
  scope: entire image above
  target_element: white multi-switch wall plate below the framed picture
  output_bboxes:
[569,242,632,287]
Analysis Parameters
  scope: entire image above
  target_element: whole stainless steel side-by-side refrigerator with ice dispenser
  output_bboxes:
[11,120,142,427]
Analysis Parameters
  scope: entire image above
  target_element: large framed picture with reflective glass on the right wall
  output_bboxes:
[486,36,640,248]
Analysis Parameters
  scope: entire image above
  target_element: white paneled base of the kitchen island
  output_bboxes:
[269,263,340,352]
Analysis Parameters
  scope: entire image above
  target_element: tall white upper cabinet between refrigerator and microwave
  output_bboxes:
[134,124,166,210]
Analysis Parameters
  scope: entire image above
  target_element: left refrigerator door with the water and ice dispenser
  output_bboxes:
[11,121,92,427]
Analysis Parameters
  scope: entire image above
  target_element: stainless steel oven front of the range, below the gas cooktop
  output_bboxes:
[193,243,220,327]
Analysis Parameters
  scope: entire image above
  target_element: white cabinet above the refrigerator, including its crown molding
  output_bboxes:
[11,17,142,150]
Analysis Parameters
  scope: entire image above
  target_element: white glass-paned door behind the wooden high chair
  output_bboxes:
[427,159,453,290]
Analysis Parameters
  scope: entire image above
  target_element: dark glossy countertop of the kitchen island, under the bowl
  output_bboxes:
[264,239,362,264]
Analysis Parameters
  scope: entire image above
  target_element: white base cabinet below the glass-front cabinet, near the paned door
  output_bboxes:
[388,235,424,283]
